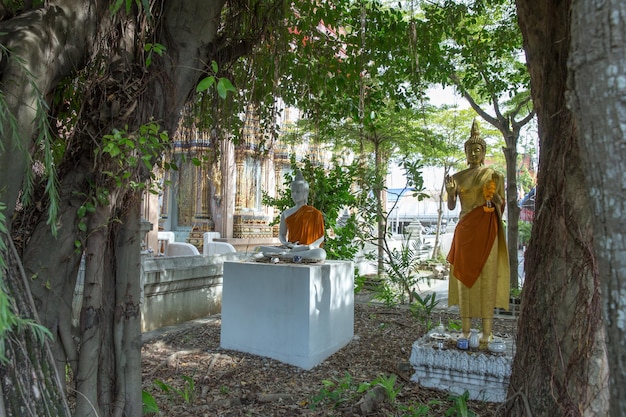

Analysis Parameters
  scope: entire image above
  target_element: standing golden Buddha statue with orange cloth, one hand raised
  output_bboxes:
[445,120,510,342]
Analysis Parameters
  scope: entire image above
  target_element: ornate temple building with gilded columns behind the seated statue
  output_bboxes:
[143,108,330,253]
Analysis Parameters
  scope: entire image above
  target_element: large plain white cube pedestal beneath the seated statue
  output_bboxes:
[220,261,354,369]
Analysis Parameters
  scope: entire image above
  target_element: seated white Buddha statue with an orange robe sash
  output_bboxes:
[257,171,326,262]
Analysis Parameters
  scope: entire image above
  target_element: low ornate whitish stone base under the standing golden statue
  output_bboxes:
[410,334,513,402]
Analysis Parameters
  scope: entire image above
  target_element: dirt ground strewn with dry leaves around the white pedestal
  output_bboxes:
[142,303,516,417]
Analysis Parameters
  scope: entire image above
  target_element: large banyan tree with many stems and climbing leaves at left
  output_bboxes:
[0,0,283,416]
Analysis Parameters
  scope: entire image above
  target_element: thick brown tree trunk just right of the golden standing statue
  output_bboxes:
[504,0,608,416]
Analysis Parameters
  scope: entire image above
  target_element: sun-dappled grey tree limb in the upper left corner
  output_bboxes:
[0,0,108,218]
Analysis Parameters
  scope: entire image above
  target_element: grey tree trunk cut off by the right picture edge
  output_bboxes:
[569,0,626,417]
